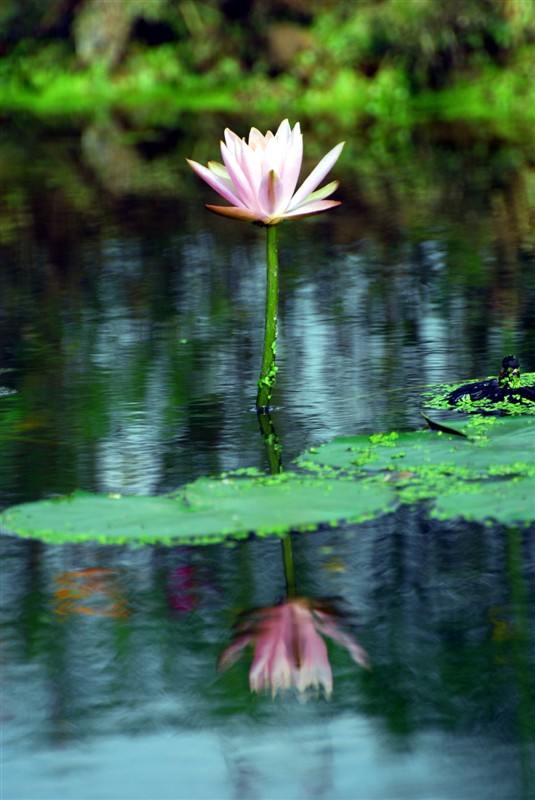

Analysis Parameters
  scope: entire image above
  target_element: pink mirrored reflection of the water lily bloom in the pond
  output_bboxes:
[219,597,369,697]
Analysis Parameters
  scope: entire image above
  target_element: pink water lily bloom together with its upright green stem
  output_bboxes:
[186,119,344,411]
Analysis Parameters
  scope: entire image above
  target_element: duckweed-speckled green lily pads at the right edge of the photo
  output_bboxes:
[298,415,535,524]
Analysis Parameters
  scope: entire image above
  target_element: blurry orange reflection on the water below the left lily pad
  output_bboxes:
[54,567,130,619]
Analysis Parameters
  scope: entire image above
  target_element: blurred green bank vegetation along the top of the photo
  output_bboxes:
[0,0,535,135]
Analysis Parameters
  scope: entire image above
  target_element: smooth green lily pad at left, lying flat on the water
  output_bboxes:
[3,473,397,544]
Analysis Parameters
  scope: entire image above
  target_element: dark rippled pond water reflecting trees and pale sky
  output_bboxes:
[0,119,535,800]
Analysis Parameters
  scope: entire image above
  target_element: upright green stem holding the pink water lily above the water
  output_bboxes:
[256,225,279,411]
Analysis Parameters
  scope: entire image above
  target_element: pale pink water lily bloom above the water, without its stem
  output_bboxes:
[186,119,344,225]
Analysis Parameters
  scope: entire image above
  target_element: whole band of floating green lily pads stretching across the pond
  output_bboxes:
[2,414,535,545]
